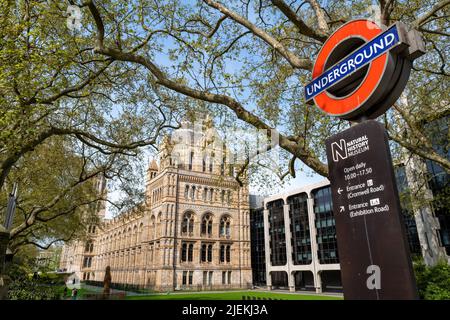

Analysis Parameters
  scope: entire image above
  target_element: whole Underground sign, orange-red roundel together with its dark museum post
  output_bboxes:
[305,19,425,300]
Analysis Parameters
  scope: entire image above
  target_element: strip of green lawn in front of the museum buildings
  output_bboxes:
[126,291,342,300]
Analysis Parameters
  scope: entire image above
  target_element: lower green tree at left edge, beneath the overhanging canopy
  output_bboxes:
[1,137,108,254]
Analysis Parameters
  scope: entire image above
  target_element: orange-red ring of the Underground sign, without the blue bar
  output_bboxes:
[313,20,389,116]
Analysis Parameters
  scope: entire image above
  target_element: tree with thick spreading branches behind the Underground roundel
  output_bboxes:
[70,0,450,180]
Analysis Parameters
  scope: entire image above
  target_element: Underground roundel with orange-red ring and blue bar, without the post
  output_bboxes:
[304,20,424,121]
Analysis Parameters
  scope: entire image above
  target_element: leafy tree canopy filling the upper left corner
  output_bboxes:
[0,0,182,192]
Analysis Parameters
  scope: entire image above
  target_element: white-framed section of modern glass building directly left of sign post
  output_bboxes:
[260,180,342,292]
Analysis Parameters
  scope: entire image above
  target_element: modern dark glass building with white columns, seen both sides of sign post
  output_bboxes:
[250,166,450,292]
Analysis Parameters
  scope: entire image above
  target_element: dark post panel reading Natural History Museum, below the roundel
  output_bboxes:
[326,120,418,300]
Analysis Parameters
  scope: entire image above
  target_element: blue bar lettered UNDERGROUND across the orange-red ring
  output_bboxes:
[305,25,400,101]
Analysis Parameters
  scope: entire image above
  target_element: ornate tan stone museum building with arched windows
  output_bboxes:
[60,119,252,291]
